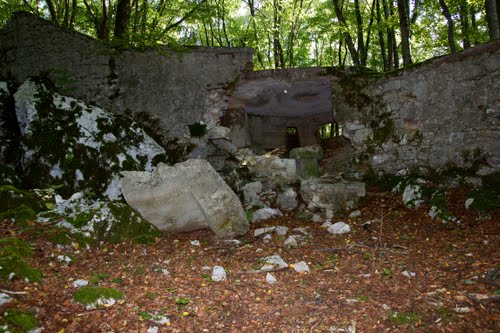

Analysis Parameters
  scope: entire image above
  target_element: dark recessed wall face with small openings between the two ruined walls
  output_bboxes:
[228,68,333,152]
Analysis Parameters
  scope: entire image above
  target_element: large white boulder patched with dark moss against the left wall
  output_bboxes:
[14,78,165,200]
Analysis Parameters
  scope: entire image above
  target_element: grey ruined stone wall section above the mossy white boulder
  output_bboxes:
[0,13,253,139]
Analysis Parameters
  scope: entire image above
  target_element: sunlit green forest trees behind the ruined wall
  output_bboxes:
[0,0,500,71]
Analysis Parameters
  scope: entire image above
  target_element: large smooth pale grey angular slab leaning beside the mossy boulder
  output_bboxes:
[121,159,248,238]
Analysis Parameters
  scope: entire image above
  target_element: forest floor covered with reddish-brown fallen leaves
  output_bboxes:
[0,191,500,333]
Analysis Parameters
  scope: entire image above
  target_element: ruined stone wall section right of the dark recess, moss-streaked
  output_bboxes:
[332,41,500,174]
